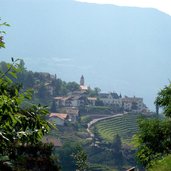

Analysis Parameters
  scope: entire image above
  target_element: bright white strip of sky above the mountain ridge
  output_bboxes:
[76,0,171,15]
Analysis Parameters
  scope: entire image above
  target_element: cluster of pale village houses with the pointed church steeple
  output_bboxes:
[49,76,148,125]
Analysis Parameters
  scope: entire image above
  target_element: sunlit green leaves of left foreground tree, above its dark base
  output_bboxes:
[0,58,49,154]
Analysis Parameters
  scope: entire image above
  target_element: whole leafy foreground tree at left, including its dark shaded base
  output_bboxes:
[0,23,59,171]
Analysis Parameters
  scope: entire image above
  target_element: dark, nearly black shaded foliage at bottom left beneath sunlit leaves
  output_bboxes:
[13,143,60,171]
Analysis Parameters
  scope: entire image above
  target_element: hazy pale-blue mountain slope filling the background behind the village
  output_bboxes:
[0,0,171,110]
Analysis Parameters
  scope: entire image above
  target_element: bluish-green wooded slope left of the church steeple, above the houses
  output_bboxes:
[0,60,79,105]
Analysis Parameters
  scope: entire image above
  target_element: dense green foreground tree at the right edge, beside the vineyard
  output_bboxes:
[136,83,171,167]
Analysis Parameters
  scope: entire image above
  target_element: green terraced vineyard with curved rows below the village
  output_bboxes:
[92,114,140,143]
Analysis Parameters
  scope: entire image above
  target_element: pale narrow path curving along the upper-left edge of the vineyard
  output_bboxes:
[87,114,123,137]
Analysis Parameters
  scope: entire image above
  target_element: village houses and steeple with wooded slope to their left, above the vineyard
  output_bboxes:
[0,60,149,125]
